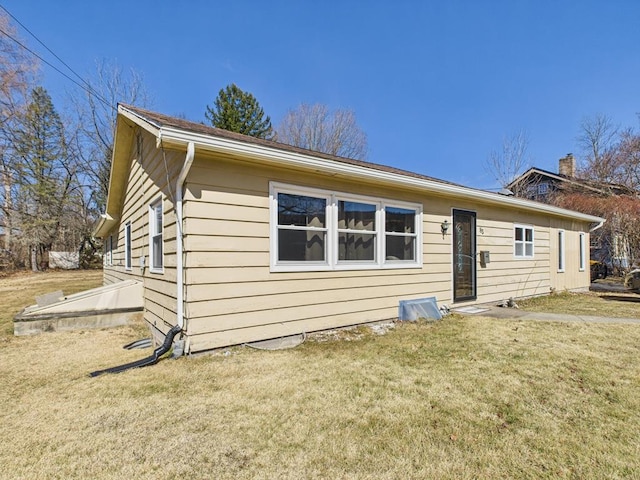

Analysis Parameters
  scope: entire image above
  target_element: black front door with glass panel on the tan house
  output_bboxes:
[453,210,476,302]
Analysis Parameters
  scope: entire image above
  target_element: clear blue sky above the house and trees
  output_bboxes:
[0,0,640,188]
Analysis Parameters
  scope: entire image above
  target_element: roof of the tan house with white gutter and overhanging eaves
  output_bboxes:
[94,105,604,237]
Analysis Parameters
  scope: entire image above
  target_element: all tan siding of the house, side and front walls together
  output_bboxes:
[105,139,588,352]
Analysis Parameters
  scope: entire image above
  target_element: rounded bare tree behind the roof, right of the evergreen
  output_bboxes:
[276,103,368,160]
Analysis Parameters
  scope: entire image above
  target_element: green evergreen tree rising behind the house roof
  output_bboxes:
[204,83,273,139]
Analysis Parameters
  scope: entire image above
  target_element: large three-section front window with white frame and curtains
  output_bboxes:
[271,183,422,271]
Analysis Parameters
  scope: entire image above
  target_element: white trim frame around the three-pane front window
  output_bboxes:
[269,182,422,272]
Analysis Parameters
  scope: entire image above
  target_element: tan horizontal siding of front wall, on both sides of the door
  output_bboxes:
[179,155,568,351]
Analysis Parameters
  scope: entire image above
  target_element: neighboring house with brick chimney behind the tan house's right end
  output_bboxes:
[506,153,635,269]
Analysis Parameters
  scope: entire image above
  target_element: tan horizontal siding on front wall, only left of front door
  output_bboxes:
[185,155,451,351]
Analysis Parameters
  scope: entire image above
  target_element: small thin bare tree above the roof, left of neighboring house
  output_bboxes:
[485,130,531,195]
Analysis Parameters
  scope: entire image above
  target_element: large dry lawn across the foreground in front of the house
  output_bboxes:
[0,272,640,479]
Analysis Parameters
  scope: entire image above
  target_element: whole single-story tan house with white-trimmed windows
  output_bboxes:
[95,105,603,353]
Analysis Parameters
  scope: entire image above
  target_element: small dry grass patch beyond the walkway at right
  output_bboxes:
[518,292,640,319]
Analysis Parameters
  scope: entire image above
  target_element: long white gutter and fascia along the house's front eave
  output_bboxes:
[160,127,603,223]
